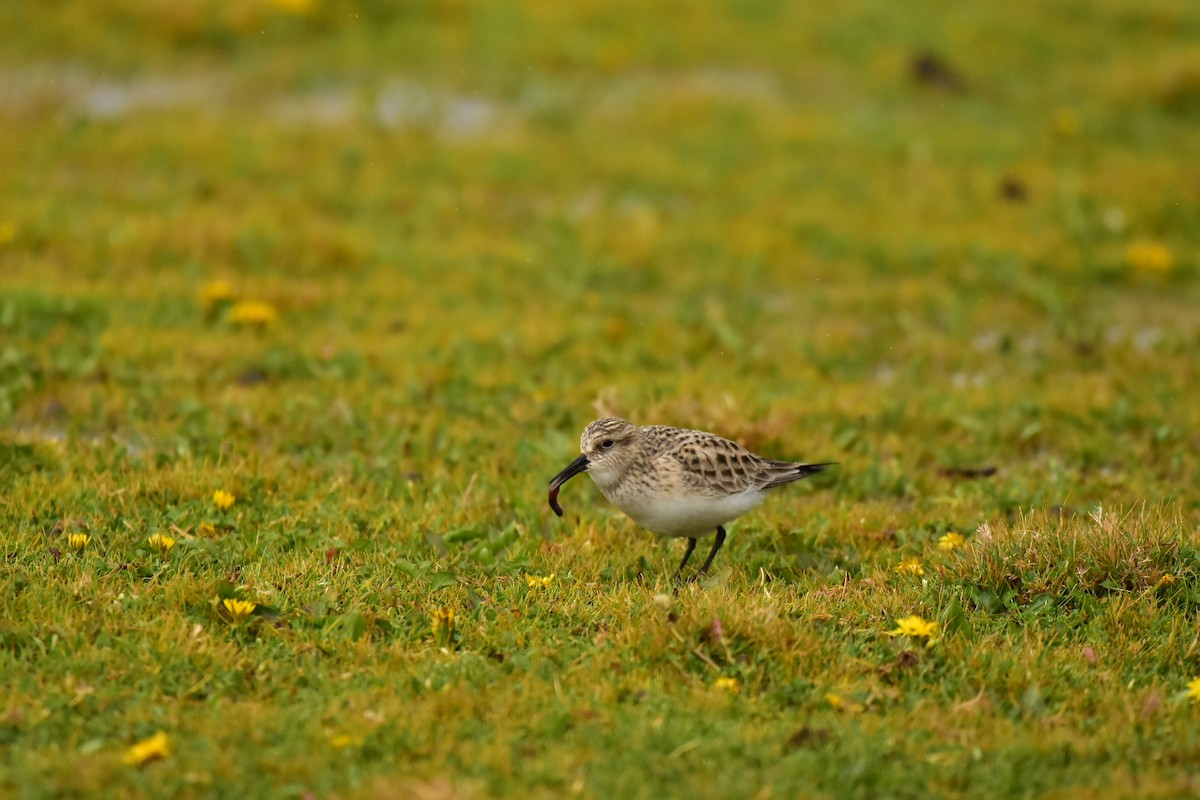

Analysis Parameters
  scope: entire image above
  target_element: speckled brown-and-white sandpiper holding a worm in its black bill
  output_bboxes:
[550,416,833,579]
